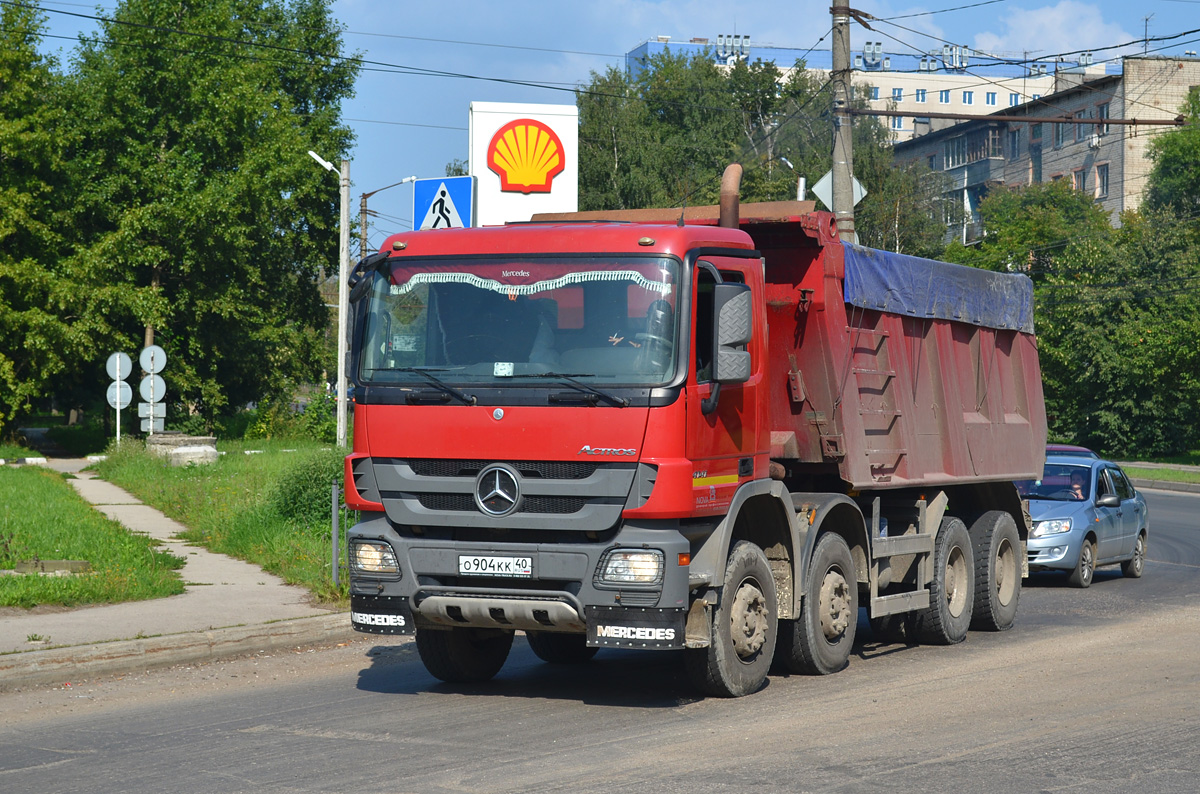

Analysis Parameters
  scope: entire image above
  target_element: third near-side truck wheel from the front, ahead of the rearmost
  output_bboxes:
[914,516,974,645]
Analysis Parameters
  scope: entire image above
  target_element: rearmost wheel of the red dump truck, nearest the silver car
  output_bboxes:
[971,510,1021,631]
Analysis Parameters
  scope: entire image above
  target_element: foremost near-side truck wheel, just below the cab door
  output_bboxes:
[684,541,779,698]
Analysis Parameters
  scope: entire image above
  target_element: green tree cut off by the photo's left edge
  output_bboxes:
[0,5,78,432]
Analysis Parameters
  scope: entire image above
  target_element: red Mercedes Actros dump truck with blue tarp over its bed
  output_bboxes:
[346,171,1045,697]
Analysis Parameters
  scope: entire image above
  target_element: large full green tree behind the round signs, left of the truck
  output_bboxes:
[60,0,358,425]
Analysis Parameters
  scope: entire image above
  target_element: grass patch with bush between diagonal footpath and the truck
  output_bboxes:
[95,440,348,603]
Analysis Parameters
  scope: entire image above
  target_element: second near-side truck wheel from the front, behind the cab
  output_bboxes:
[775,533,858,675]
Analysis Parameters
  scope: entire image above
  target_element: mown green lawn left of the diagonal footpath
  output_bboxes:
[0,467,184,607]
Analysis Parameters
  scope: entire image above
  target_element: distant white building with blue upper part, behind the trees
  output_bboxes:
[625,35,1099,142]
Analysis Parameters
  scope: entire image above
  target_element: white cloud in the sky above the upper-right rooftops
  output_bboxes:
[974,0,1135,58]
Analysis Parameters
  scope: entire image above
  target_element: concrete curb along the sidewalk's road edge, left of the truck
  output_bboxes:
[0,612,358,692]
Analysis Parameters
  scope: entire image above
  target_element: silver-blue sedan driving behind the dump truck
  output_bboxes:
[1016,455,1150,588]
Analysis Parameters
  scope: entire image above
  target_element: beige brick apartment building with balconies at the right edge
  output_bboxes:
[895,56,1200,242]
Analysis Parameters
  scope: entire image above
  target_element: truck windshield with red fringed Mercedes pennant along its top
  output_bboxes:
[359,257,679,386]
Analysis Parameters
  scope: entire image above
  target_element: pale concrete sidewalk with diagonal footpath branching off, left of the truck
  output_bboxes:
[0,458,355,690]
